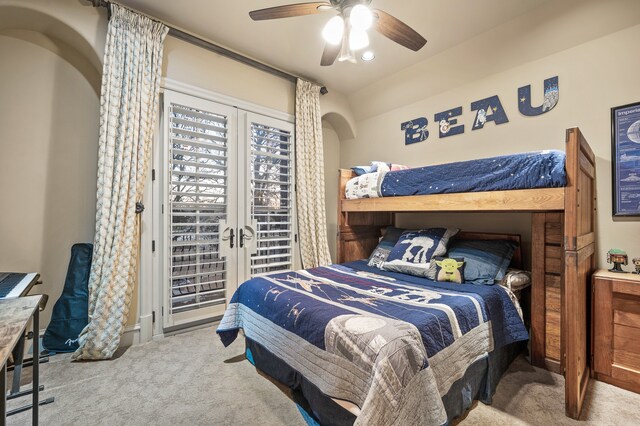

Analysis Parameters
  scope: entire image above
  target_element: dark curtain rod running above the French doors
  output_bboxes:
[87,0,329,95]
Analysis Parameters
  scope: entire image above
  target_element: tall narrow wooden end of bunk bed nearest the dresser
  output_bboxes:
[561,128,596,419]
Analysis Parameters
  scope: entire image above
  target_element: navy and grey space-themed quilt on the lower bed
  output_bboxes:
[217,261,528,425]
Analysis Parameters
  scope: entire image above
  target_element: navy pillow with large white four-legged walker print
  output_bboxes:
[382,228,459,276]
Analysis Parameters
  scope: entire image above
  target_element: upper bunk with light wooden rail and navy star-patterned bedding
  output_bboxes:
[338,128,595,213]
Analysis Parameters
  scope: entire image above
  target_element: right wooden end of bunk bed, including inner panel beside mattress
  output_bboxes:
[531,128,596,418]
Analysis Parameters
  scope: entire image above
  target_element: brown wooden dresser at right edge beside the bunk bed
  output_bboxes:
[591,270,640,392]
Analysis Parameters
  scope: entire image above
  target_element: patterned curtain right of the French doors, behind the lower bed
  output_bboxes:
[295,79,331,268]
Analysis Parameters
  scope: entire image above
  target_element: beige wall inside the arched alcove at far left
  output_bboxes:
[0,33,98,328]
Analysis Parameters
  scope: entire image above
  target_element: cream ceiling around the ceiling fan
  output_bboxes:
[120,0,549,95]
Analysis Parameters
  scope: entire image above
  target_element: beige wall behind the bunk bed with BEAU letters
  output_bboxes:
[340,1,640,266]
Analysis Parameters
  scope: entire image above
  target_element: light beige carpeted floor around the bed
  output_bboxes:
[8,328,640,426]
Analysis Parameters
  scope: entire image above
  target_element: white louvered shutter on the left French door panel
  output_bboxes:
[168,103,230,315]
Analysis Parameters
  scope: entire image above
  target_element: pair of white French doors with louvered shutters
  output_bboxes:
[160,90,297,328]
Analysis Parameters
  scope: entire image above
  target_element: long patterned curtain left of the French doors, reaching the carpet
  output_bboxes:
[73,3,168,360]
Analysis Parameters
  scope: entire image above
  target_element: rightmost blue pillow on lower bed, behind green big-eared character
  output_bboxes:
[447,240,517,285]
